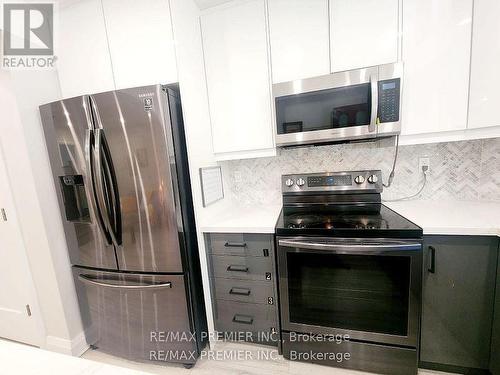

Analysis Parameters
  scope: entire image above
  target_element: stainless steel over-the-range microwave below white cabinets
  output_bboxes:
[273,63,403,146]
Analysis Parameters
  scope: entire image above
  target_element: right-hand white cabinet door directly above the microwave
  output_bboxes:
[330,0,400,72]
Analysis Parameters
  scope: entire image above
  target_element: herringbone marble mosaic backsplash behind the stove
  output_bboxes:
[220,138,500,205]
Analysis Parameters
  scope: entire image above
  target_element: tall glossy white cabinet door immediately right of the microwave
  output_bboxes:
[401,0,472,134]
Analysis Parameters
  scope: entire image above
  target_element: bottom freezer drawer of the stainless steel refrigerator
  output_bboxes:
[73,267,199,364]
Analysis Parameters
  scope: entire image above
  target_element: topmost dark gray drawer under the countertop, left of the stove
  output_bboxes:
[210,233,273,257]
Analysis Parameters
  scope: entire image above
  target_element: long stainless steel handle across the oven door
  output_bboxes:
[278,239,422,254]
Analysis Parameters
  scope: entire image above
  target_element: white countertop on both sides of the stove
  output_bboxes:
[200,200,500,236]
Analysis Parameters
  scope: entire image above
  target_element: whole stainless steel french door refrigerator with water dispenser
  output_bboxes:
[40,85,207,366]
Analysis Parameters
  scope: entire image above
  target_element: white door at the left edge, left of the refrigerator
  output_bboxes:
[0,145,41,345]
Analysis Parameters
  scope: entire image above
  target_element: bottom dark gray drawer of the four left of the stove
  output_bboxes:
[215,300,278,344]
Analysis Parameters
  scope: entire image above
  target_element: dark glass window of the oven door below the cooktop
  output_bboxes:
[287,253,411,336]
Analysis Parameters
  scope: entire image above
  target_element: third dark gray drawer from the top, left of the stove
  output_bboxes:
[214,278,277,305]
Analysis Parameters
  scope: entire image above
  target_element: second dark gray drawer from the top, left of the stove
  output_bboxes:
[211,255,274,281]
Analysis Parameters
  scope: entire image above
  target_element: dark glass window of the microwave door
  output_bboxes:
[276,83,371,134]
